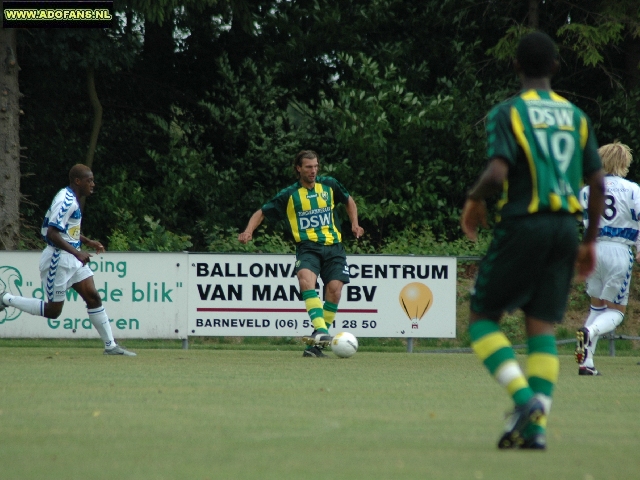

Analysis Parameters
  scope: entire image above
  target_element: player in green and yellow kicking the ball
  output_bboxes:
[238,150,364,357]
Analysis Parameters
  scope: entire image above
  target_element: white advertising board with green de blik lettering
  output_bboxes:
[0,251,189,339]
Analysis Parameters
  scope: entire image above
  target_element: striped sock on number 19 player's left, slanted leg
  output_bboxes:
[469,320,533,405]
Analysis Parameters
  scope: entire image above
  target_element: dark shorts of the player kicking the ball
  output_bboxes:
[295,242,349,285]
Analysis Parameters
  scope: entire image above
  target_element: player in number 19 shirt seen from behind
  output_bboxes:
[461,32,604,449]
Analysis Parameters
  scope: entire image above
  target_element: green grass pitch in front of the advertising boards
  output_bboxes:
[0,342,640,480]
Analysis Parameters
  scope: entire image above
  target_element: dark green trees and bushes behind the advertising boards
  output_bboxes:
[13,0,640,255]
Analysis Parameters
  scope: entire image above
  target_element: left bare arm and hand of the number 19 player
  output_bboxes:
[460,158,509,242]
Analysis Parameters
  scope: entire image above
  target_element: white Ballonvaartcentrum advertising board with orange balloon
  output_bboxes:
[188,254,457,338]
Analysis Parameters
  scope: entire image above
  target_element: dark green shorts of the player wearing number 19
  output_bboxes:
[471,213,578,323]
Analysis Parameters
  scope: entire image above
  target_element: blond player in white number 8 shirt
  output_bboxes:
[575,141,640,376]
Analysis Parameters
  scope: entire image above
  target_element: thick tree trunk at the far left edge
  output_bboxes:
[0,27,20,250]
